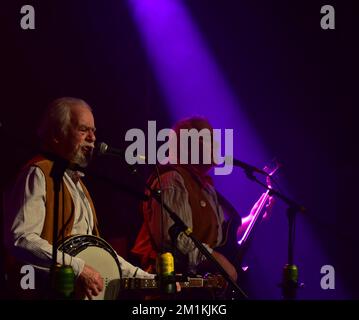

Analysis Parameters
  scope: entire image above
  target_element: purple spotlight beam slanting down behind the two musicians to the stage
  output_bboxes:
[128,0,344,298]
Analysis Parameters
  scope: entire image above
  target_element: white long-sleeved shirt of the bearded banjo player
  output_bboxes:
[4,166,154,278]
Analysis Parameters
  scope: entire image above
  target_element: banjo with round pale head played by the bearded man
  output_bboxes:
[59,235,226,300]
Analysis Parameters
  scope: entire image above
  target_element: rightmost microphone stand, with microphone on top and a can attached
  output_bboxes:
[244,168,306,300]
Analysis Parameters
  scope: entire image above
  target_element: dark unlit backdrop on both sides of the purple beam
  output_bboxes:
[0,0,359,299]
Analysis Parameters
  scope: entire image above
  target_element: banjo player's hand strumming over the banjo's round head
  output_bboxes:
[76,265,103,300]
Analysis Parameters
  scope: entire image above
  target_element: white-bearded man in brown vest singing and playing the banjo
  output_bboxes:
[5,97,154,299]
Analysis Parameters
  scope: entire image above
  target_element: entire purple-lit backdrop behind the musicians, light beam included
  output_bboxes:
[0,0,359,299]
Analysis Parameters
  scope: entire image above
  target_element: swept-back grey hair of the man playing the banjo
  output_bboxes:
[37,97,92,143]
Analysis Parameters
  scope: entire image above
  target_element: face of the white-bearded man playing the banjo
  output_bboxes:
[58,105,96,167]
